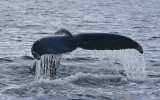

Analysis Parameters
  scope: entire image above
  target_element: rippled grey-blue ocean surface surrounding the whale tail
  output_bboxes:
[0,0,160,100]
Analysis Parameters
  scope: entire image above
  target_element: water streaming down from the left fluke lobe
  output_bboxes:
[36,54,61,79]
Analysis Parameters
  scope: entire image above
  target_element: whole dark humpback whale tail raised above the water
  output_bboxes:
[31,29,143,74]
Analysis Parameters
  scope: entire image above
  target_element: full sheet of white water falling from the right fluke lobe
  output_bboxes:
[97,49,147,79]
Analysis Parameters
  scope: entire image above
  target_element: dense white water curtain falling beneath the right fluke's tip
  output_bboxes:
[121,50,146,79]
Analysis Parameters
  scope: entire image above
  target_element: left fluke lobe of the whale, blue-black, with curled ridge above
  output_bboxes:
[31,29,77,60]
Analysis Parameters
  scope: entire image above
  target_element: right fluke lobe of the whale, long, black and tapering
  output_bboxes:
[75,33,143,53]
